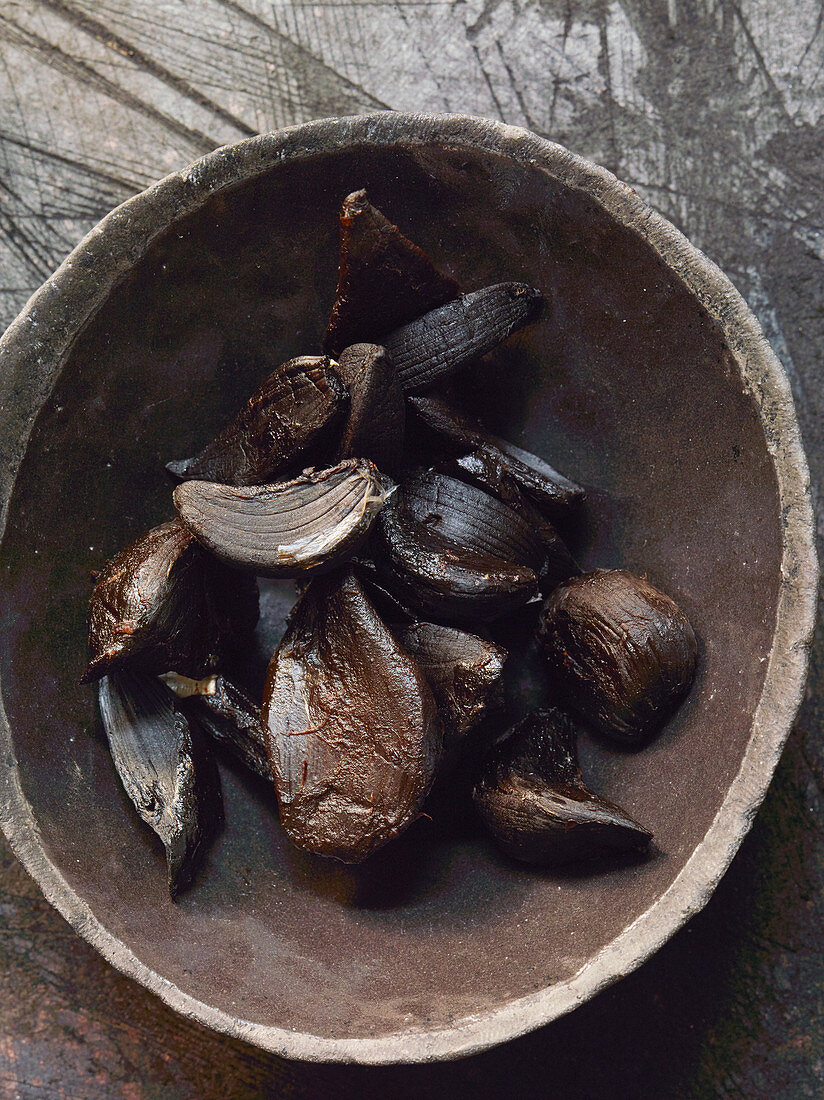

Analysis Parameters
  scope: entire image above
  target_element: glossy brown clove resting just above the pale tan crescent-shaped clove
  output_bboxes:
[166,355,347,485]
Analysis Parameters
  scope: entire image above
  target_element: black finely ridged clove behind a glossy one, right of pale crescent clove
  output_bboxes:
[400,470,580,585]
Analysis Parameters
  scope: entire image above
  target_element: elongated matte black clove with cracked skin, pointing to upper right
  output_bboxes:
[383,283,543,394]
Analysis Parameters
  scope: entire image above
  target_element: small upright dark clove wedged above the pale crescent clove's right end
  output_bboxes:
[336,343,406,474]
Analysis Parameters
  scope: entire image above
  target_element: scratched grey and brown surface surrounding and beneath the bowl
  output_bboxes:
[0,0,824,1100]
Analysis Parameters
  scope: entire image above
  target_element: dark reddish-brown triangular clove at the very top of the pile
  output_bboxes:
[323,190,461,355]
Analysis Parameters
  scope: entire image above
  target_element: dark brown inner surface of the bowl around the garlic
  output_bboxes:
[0,116,814,1058]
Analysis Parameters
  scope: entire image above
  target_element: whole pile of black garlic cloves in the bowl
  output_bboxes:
[84,191,697,897]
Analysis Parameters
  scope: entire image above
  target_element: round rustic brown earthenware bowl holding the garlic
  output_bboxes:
[0,113,816,1063]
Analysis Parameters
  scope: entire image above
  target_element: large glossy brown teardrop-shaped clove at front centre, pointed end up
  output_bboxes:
[262,570,442,864]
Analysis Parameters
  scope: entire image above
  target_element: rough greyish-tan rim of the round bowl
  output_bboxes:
[0,111,817,1064]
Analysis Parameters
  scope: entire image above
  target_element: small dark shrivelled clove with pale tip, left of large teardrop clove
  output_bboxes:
[161,673,272,782]
